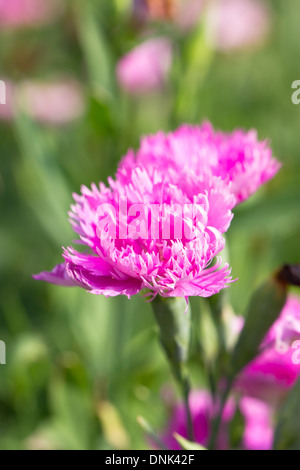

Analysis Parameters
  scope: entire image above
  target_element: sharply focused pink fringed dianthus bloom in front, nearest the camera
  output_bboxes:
[35,164,235,297]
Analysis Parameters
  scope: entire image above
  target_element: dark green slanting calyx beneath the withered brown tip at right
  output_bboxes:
[231,279,287,379]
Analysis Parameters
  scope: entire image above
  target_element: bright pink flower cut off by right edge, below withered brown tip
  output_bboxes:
[235,296,300,405]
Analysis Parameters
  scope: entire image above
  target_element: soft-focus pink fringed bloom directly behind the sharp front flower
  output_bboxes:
[120,122,280,206]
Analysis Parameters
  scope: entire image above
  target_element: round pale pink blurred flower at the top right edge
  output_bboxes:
[206,0,270,51]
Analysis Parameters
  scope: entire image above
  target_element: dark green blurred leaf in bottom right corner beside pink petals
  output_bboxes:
[274,380,300,450]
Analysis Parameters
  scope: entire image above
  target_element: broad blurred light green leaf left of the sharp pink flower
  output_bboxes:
[14,112,72,244]
